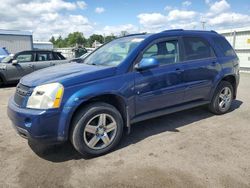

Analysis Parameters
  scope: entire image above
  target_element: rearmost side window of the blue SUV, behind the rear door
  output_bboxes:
[213,37,236,57]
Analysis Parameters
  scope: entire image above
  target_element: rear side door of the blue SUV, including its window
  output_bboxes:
[182,36,220,102]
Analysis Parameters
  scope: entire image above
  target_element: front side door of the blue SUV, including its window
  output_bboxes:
[135,38,185,115]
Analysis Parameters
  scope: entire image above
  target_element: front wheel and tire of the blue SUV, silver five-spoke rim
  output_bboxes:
[70,102,123,157]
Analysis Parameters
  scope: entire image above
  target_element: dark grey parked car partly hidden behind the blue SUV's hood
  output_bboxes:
[0,50,69,85]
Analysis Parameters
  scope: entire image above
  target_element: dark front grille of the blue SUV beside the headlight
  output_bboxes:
[14,83,30,107]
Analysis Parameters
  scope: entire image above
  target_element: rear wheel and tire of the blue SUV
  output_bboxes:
[209,81,234,115]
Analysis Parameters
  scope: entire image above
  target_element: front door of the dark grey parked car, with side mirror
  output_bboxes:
[7,52,35,81]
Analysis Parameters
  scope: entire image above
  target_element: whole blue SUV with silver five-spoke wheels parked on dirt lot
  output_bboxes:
[8,30,239,156]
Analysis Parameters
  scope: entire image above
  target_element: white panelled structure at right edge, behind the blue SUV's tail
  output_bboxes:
[218,27,250,70]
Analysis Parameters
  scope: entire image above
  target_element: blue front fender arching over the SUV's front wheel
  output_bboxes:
[58,75,135,140]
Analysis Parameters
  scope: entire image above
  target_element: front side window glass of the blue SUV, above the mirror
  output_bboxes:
[143,40,179,65]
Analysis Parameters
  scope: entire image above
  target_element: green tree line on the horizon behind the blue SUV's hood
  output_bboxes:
[49,32,120,48]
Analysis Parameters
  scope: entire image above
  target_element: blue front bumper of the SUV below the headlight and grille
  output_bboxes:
[8,97,64,144]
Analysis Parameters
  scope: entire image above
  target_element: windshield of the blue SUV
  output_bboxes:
[84,36,144,66]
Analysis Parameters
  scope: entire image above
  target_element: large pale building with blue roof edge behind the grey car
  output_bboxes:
[0,29,33,53]
